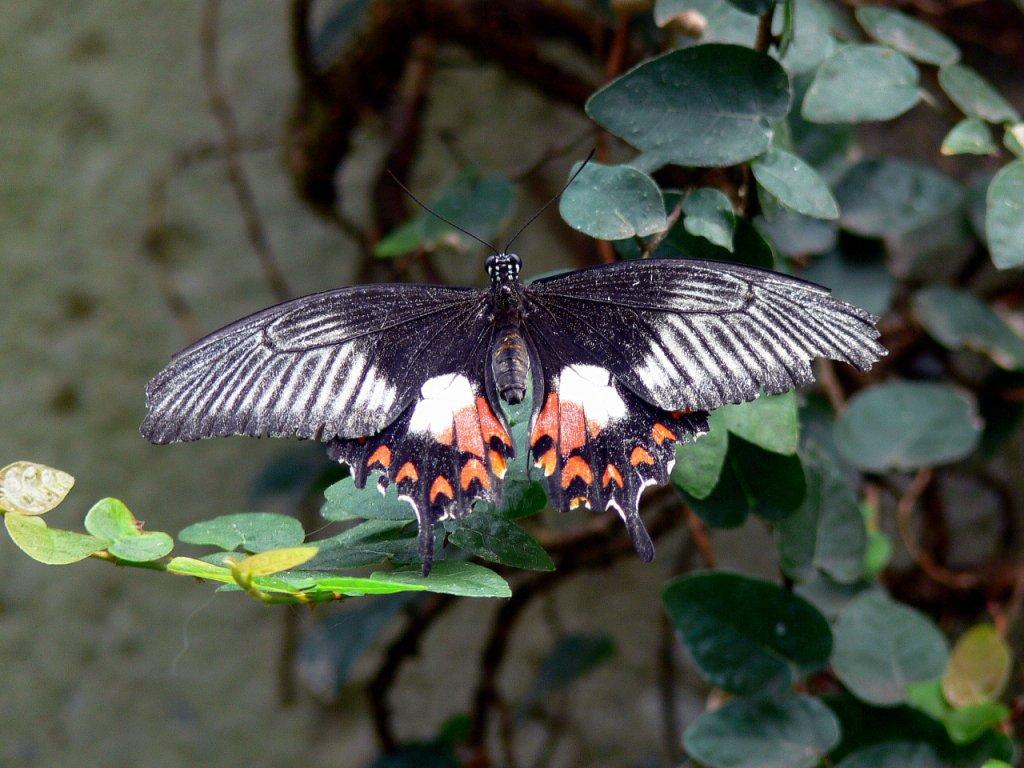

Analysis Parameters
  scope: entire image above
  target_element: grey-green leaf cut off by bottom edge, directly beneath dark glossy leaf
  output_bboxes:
[683,695,840,768]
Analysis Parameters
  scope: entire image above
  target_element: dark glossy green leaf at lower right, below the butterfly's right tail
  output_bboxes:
[662,572,833,693]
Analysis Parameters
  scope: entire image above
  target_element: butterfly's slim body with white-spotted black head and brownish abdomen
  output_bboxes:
[486,253,529,404]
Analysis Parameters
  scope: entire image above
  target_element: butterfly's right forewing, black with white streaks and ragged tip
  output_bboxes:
[526,259,886,411]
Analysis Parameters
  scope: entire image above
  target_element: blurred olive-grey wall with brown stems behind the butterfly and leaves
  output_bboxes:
[0,0,1024,768]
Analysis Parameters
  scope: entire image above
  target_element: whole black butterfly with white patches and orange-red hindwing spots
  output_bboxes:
[142,162,886,572]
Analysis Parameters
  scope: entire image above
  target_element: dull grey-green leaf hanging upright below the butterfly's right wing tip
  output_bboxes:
[775,451,867,584]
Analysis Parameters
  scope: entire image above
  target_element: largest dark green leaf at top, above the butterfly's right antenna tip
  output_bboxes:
[586,44,792,167]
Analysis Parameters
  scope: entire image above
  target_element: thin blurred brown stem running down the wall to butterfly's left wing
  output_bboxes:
[200,0,291,301]
